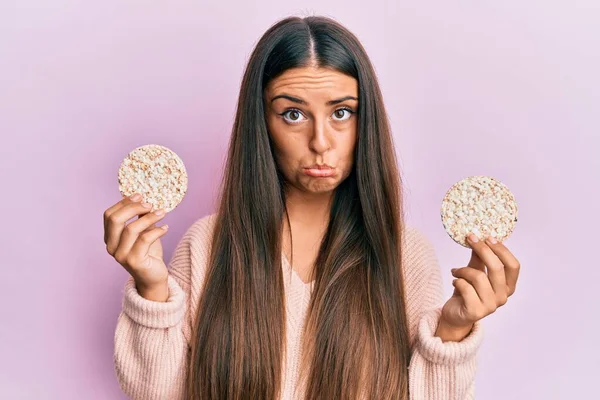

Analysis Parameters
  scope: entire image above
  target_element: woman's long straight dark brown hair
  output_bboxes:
[186,16,410,400]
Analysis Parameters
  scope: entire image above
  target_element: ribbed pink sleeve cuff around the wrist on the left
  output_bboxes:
[123,275,185,328]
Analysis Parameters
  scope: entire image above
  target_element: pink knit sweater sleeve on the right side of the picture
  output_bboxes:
[409,228,483,400]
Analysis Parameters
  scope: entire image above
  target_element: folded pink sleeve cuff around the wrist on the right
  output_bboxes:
[417,307,483,366]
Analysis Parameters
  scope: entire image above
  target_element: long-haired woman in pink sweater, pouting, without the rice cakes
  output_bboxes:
[104,16,519,400]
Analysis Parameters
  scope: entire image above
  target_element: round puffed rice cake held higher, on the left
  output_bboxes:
[119,144,188,212]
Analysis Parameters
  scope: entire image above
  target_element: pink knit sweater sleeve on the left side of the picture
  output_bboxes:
[114,217,210,400]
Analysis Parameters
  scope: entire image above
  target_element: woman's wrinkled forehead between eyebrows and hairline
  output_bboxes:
[266,67,358,97]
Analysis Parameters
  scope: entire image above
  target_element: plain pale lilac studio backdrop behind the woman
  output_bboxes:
[0,0,600,400]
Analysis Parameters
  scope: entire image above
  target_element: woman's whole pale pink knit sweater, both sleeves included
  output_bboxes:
[114,214,483,400]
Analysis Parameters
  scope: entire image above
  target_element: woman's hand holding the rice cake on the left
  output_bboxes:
[104,194,169,301]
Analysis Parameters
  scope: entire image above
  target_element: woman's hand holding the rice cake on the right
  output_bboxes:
[440,231,521,331]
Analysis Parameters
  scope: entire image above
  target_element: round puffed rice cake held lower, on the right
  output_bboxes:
[441,175,517,248]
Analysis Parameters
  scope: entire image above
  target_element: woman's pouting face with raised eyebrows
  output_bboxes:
[265,67,358,193]
